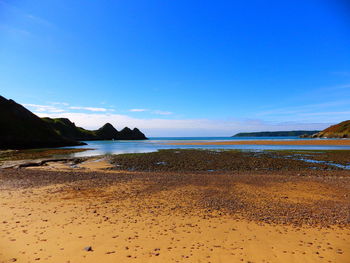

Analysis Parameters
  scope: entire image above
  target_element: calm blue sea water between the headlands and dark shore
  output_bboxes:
[60,137,350,157]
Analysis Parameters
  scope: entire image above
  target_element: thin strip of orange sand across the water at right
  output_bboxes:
[167,139,350,146]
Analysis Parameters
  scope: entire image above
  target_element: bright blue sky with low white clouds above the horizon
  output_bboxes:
[0,0,350,136]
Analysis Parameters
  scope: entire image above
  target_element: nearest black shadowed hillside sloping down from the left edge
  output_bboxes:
[0,96,84,149]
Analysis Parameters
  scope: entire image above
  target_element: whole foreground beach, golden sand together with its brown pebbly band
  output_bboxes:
[0,159,350,263]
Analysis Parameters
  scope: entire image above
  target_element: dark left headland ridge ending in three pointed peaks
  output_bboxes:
[0,96,147,149]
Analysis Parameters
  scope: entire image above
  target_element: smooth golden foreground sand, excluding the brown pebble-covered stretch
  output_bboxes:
[0,160,350,263]
